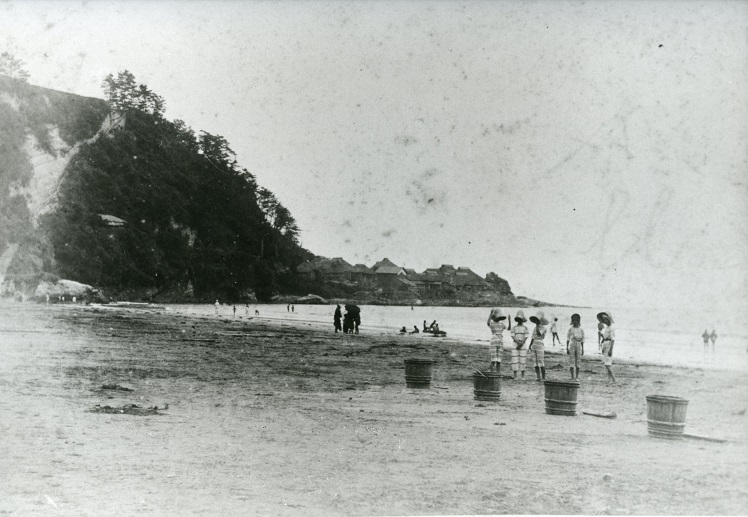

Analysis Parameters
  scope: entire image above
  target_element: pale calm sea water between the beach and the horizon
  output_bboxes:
[166,304,748,372]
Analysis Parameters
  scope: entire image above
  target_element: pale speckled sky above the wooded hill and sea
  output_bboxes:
[0,0,748,310]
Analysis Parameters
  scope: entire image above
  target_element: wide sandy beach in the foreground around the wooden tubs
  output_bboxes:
[0,304,748,516]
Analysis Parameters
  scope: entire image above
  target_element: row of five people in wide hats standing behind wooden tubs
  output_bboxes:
[486,307,616,383]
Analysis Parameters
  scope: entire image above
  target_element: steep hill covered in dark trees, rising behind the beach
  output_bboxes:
[0,72,313,300]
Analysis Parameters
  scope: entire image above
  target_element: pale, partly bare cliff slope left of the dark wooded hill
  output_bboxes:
[0,76,111,290]
